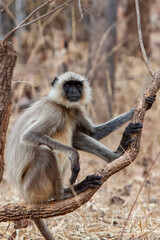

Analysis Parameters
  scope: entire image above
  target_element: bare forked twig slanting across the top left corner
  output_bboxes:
[3,0,73,42]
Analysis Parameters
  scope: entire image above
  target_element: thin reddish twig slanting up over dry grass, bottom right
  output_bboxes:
[121,152,160,239]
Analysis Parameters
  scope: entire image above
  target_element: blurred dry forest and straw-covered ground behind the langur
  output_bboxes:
[0,0,160,240]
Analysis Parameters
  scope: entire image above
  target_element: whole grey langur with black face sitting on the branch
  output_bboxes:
[5,72,155,240]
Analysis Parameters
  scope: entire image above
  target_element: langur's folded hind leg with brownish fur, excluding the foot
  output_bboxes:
[22,148,63,203]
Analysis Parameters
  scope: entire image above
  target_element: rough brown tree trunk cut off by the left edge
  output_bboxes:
[0,41,17,181]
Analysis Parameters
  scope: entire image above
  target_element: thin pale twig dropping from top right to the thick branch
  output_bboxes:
[135,0,154,77]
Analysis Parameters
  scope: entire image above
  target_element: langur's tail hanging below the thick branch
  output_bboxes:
[34,218,55,240]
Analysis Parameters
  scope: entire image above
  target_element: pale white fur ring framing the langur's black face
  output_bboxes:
[48,72,92,108]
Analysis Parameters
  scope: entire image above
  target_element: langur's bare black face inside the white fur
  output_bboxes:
[63,81,83,102]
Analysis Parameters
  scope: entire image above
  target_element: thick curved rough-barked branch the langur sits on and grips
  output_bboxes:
[0,72,160,222]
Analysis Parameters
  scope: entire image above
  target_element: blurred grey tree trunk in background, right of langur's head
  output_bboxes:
[88,0,117,121]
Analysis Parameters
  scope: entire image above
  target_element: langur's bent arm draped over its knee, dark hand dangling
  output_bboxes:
[22,120,80,184]
